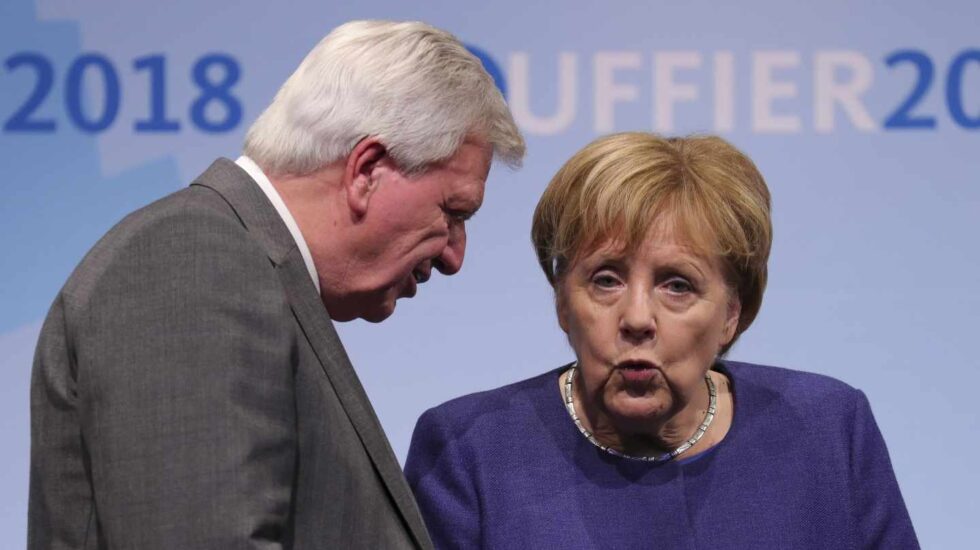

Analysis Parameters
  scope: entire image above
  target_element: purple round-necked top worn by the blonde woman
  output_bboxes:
[406,361,919,549]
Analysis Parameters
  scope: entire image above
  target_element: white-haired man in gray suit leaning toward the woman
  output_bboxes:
[28,22,524,549]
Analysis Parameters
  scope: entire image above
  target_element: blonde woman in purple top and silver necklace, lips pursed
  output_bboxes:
[406,133,918,548]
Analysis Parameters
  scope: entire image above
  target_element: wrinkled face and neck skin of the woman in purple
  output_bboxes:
[557,223,739,454]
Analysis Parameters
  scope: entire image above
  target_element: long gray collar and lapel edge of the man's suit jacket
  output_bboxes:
[192,159,432,548]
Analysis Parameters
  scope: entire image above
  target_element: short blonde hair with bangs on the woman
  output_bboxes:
[531,132,772,353]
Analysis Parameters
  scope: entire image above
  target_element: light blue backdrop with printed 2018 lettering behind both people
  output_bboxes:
[0,0,980,548]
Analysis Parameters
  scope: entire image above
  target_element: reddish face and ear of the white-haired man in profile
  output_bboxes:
[331,141,492,322]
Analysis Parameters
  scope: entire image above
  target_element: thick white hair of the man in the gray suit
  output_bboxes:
[245,21,525,175]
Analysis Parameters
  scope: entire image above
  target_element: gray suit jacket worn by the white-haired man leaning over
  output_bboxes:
[28,159,431,550]
